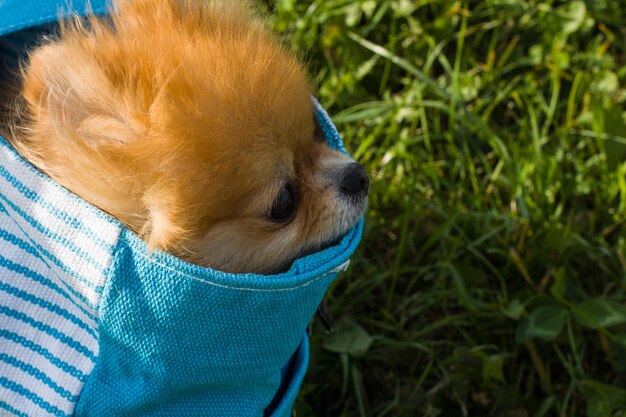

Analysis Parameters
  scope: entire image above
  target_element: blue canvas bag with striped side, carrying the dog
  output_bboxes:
[0,0,363,417]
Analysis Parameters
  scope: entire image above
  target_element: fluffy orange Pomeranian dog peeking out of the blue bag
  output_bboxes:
[1,0,369,274]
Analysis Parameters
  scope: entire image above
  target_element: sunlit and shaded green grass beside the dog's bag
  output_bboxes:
[268,0,626,417]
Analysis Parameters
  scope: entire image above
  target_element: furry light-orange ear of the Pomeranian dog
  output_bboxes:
[23,42,138,147]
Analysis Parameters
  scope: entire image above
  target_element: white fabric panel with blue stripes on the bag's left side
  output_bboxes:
[0,135,121,416]
